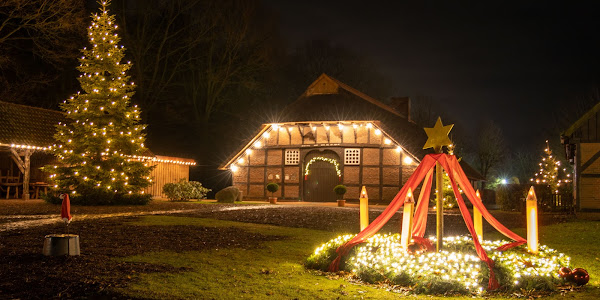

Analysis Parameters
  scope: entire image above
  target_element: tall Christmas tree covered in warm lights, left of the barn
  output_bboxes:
[45,1,151,199]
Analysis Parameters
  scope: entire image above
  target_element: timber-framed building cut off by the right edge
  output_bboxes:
[561,103,600,210]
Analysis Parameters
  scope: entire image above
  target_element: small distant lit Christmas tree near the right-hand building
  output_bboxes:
[530,141,571,193]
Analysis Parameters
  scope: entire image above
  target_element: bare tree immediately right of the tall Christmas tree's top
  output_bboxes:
[119,0,214,111]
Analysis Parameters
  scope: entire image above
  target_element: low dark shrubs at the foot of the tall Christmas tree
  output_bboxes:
[42,189,152,205]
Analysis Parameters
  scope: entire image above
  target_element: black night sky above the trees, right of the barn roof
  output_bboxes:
[264,0,600,148]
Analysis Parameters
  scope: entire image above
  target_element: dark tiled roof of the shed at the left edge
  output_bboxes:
[0,101,66,148]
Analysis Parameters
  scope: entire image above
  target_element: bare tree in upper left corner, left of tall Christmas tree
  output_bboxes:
[0,0,85,102]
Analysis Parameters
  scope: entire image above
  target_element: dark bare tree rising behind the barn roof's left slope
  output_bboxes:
[182,1,274,127]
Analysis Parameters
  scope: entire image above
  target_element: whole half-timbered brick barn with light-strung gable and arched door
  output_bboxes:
[220,74,480,203]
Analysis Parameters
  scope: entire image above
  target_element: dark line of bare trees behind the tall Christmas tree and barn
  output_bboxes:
[0,0,391,190]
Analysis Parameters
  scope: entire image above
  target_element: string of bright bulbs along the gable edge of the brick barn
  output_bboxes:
[229,121,414,172]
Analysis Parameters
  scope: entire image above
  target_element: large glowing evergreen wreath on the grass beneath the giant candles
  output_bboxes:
[306,234,589,294]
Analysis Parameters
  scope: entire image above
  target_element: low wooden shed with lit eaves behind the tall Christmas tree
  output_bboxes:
[0,101,195,199]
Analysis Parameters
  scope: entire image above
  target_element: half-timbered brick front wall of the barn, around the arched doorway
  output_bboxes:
[233,124,416,203]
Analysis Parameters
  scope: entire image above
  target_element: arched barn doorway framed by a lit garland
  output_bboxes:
[302,150,342,202]
